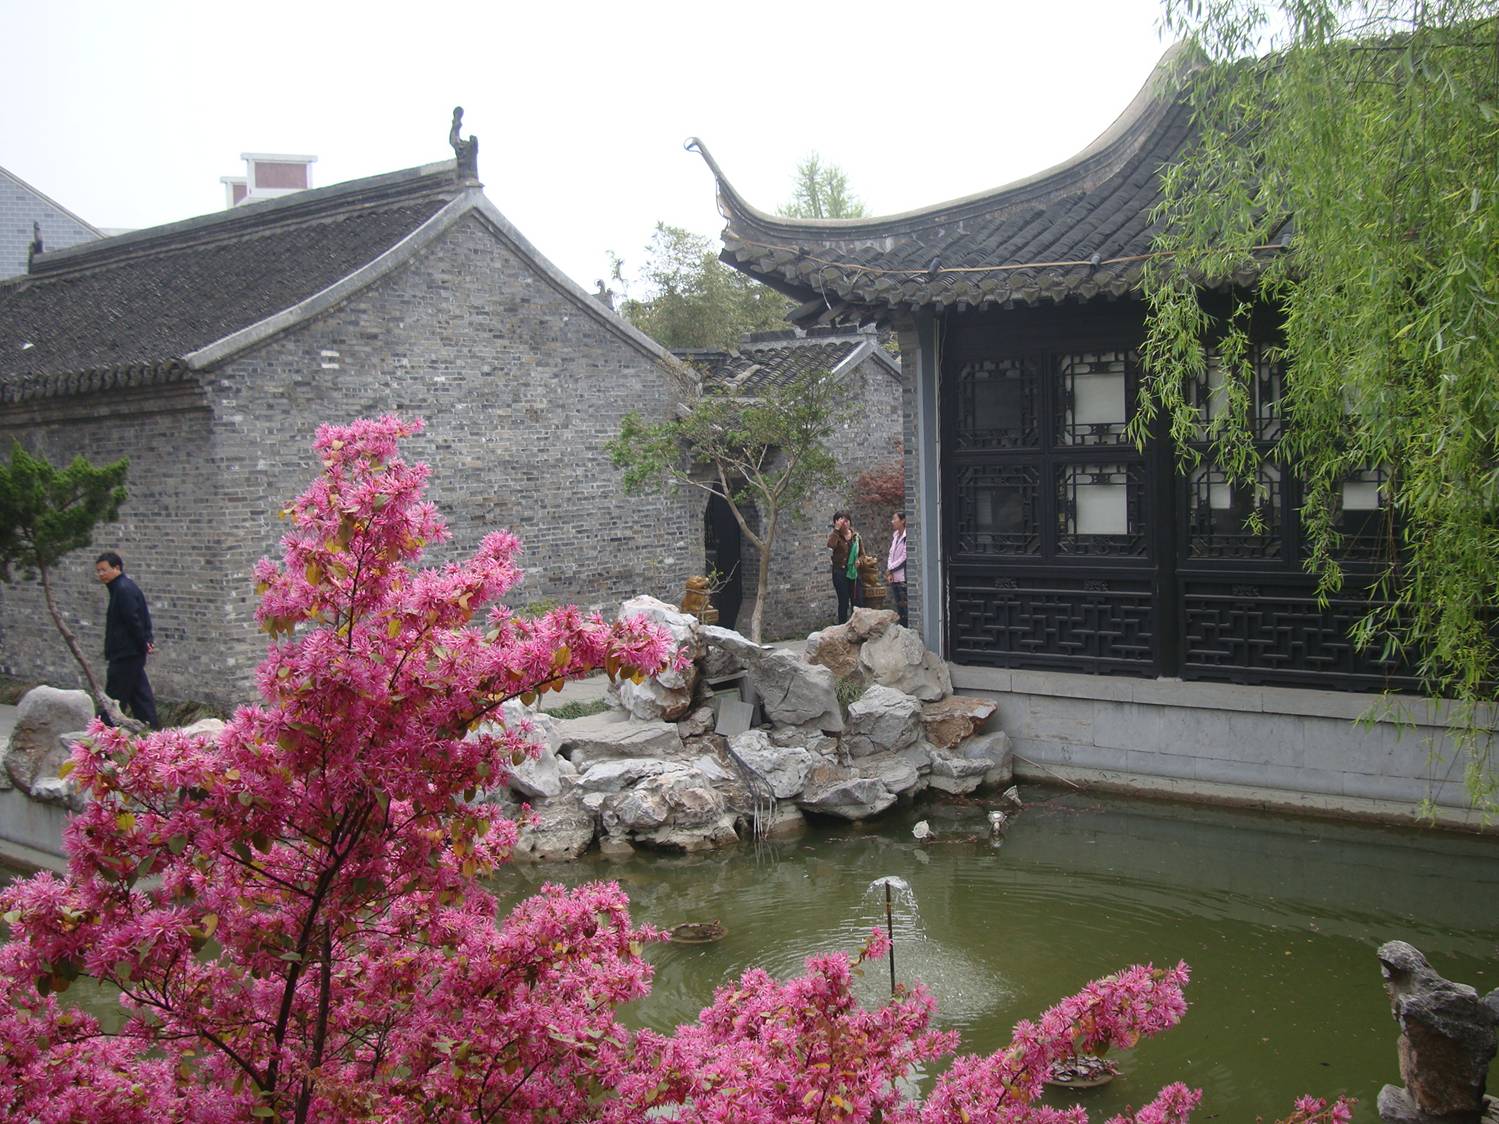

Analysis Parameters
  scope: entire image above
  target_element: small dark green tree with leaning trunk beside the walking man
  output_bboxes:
[0,441,129,722]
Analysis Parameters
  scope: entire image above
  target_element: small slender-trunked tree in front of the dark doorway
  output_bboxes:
[609,370,844,643]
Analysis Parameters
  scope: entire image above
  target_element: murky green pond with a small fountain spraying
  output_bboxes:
[498,788,1499,1121]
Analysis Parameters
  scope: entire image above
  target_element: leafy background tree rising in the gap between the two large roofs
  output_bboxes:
[615,223,791,349]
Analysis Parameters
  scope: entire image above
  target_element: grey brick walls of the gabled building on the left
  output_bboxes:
[0,216,703,701]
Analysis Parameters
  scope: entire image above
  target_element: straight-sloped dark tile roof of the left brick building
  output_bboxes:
[0,162,462,400]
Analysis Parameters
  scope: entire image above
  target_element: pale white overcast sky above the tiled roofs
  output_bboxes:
[0,0,1168,295]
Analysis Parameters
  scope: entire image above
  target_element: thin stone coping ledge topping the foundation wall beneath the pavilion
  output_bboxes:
[949,664,1495,728]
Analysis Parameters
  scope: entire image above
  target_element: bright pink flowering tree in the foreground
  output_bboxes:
[0,418,1346,1124]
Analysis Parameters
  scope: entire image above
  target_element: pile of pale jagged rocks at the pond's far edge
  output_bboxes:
[490,608,1010,859]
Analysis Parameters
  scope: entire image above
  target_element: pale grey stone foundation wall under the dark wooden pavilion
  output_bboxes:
[952,665,1478,826]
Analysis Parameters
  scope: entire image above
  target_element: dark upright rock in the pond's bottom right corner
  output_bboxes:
[1378,941,1499,1124]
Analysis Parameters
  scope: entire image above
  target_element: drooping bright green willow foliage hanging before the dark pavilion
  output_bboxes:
[1135,0,1499,812]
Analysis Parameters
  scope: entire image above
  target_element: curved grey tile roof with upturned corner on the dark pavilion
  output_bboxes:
[697,44,1277,324]
